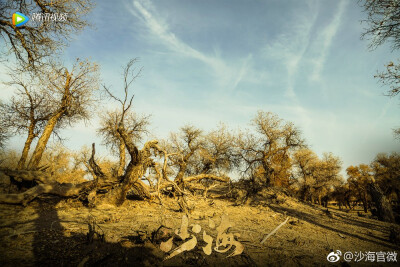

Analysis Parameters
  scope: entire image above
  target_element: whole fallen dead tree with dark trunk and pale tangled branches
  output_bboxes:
[0,132,230,209]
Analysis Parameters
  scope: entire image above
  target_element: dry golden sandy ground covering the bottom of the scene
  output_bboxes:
[0,198,400,266]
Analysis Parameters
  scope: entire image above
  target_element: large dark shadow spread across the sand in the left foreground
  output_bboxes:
[0,197,256,267]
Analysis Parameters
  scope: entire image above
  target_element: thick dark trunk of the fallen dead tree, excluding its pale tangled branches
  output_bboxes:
[0,136,158,205]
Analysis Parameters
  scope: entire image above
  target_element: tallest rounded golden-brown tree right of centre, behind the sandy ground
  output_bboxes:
[236,111,304,191]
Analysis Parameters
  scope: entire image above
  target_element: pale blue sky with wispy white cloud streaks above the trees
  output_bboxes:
[2,0,400,175]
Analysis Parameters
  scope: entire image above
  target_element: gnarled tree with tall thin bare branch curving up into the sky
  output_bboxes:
[91,59,158,205]
